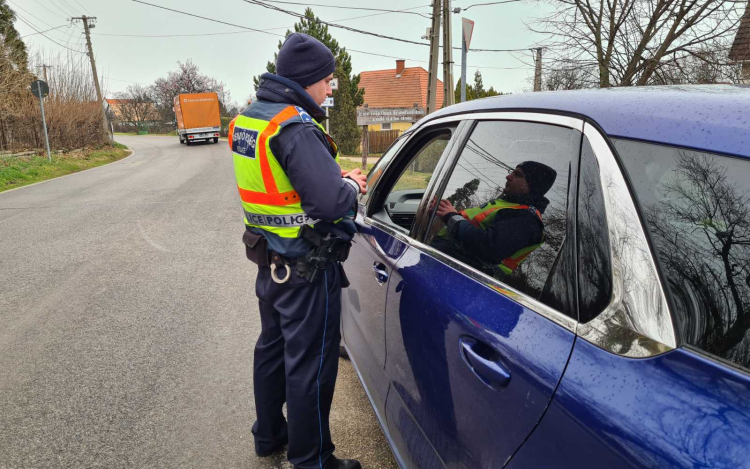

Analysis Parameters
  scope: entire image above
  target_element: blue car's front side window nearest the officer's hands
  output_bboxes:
[372,128,453,233]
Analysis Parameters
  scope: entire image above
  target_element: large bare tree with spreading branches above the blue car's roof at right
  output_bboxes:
[532,0,744,88]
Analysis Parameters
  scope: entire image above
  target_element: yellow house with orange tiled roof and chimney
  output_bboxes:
[359,60,443,132]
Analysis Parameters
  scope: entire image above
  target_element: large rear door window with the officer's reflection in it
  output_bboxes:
[427,121,581,304]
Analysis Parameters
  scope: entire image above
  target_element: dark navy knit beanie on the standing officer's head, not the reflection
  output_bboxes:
[276,33,336,88]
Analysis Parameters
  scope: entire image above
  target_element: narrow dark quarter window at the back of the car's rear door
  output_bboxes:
[577,137,612,323]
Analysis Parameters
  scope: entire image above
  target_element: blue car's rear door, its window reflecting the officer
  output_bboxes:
[386,113,583,468]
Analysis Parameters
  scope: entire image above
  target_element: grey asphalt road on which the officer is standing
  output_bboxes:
[0,136,396,468]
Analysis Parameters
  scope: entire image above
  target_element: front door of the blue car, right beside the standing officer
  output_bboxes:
[342,124,456,424]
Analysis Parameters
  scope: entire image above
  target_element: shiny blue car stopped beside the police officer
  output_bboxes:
[342,85,750,469]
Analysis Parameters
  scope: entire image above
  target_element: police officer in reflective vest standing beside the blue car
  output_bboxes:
[229,33,366,469]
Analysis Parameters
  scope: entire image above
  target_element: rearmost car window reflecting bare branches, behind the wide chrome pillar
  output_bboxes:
[615,140,750,368]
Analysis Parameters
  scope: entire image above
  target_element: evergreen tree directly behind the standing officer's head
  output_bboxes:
[253,8,365,154]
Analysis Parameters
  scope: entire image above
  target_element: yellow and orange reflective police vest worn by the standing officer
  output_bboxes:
[229,101,338,238]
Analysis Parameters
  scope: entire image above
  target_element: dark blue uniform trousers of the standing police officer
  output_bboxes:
[253,263,341,469]
